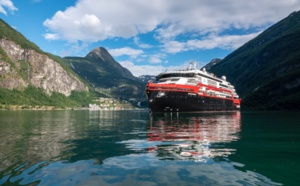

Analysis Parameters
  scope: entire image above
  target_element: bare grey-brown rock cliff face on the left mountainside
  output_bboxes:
[0,38,88,96]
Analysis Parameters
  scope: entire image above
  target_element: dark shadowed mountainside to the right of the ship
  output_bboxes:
[208,11,300,109]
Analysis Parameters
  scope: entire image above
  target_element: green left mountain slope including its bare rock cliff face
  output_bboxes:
[0,19,90,109]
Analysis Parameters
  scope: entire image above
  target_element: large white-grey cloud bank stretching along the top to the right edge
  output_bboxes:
[43,0,300,41]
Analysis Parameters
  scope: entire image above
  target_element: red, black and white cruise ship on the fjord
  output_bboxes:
[146,64,241,112]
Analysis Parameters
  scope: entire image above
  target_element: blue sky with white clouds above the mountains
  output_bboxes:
[0,0,300,76]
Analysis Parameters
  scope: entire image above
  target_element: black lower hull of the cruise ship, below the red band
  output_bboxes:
[147,91,239,112]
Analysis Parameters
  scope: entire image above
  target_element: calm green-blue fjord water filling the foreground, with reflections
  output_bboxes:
[0,111,300,185]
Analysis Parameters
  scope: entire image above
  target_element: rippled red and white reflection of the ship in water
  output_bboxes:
[148,112,241,161]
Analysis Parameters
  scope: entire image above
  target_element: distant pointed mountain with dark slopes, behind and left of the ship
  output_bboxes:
[64,47,145,99]
